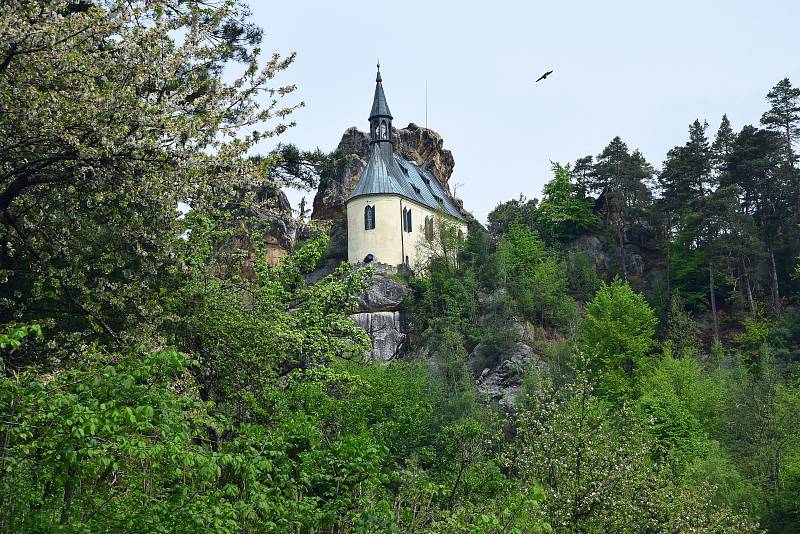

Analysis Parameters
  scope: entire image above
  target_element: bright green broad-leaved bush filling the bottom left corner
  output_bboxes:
[0,350,225,532]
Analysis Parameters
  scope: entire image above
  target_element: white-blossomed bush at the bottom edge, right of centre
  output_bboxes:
[514,373,757,532]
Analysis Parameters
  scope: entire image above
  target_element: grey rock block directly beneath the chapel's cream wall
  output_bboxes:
[351,274,411,362]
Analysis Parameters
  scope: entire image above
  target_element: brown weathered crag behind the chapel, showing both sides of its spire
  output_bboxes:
[311,123,455,219]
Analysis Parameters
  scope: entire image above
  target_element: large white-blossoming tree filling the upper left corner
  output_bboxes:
[0,0,301,346]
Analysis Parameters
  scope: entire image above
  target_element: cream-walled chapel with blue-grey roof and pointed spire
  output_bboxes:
[347,66,467,269]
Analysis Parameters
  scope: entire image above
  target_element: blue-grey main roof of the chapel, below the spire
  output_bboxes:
[347,149,464,220]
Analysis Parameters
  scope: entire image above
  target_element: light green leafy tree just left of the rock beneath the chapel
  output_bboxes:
[166,218,369,418]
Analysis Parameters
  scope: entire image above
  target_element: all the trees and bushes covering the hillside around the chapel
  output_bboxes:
[0,0,800,533]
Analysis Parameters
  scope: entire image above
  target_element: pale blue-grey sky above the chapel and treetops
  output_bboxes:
[250,0,800,221]
